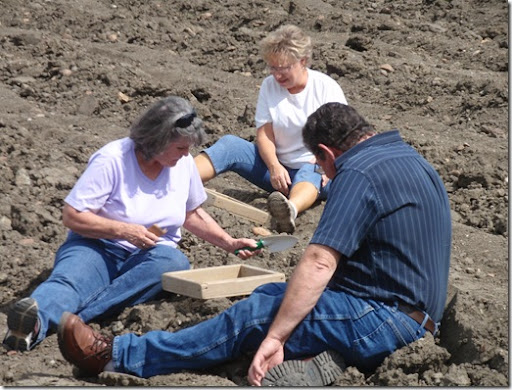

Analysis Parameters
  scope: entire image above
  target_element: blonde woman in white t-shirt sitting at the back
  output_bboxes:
[195,25,347,233]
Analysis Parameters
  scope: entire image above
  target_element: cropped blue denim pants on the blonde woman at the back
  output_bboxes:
[203,135,330,199]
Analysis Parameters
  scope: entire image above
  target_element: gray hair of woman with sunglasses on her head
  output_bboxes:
[130,96,206,160]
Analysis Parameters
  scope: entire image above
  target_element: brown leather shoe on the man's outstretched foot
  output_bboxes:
[58,312,112,375]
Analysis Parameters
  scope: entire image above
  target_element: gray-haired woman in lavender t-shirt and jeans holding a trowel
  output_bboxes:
[4,96,257,350]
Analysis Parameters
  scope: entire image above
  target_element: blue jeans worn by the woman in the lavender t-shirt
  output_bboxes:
[31,233,190,343]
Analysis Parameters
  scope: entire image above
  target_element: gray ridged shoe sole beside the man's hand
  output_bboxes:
[261,350,346,386]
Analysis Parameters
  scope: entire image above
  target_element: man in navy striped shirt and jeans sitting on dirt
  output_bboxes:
[59,103,451,386]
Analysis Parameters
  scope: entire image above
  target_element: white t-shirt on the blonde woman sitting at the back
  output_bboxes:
[255,69,347,169]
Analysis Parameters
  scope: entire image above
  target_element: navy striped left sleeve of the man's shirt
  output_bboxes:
[311,171,379,257]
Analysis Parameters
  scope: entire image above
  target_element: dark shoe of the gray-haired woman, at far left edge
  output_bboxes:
[3,298,40,351]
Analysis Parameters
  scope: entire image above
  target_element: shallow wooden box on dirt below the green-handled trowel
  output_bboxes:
[162,264,285,299]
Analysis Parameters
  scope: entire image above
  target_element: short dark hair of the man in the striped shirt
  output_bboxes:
[302,103,375,158]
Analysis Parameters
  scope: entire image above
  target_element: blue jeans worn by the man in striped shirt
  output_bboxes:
[112,283,432,377]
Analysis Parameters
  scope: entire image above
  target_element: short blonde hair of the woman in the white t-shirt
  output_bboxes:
[260,24,313,65]
